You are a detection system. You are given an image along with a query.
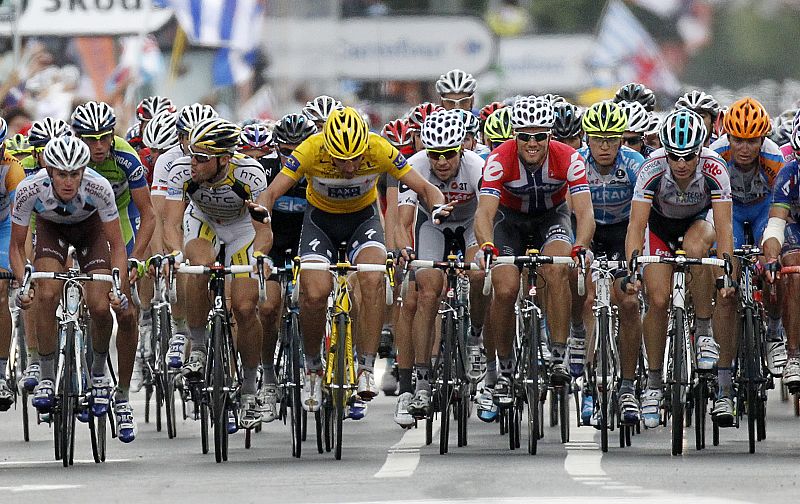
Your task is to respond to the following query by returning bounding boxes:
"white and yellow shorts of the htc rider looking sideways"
[183,203,256,278]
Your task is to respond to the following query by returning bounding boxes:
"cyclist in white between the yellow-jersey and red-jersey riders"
[395,111,485,428]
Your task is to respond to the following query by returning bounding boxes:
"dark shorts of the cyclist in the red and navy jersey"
[494,203,574,256]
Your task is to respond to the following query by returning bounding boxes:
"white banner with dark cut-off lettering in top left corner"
[0,0,172,36]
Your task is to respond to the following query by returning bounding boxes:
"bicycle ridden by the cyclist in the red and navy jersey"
[483,249,574,455]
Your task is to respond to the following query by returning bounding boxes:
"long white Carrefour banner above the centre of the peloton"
[264,16,495,80]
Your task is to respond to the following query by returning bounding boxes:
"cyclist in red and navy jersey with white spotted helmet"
[475,98,594,407]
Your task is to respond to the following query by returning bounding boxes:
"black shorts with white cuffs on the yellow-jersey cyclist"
[300,204,386,263]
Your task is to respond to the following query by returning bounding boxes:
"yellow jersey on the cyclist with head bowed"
[281,133,411,214]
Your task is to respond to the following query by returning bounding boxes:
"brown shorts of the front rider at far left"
[34,212,111,273]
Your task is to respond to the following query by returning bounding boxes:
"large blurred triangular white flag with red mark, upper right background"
[589,0,681,95]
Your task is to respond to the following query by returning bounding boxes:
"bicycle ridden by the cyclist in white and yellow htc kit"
[177,254,264,463]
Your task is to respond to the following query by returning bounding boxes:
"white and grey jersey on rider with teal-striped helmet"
[633,147,731,219]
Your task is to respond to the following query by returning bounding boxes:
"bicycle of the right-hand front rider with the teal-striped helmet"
[631,250,731,455]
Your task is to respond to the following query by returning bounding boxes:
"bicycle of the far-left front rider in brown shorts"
[22,265,120,467]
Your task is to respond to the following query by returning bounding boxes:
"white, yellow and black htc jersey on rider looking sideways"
[167,154,267,225]
